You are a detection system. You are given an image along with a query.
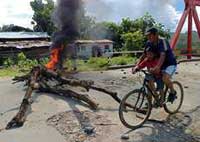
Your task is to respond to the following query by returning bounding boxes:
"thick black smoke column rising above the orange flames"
[52,0,82,40]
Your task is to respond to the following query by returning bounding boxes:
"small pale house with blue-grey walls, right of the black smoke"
[75,39,113,59]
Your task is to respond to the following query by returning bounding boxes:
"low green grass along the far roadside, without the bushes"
[0,56,136,77]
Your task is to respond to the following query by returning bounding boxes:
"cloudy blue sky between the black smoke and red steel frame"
[84,0,180,29]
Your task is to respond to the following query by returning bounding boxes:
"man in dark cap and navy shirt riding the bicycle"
[133,28,177,102]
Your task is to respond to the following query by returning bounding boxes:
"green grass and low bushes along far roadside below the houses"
[0,53,137,77]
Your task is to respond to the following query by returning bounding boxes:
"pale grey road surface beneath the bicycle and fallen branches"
[0,62,200,142]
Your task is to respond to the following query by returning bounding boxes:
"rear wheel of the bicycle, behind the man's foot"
[164,81,184,114]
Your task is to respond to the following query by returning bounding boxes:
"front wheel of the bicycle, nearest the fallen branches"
[119,89,152,129]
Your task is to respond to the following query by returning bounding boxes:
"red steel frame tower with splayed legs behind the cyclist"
[170,0,200,59]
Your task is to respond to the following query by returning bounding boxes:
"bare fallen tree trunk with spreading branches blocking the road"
[6,66,121,129]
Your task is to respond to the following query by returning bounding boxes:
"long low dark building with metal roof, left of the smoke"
[0,32,51,59]
